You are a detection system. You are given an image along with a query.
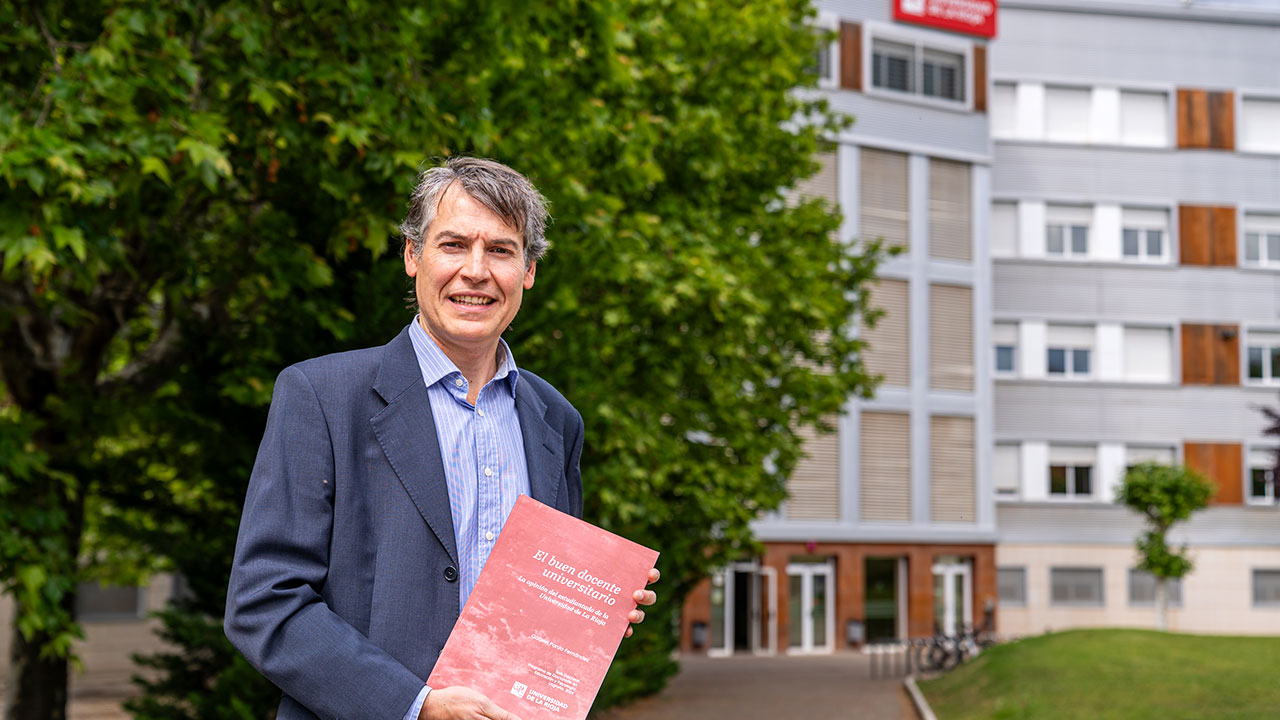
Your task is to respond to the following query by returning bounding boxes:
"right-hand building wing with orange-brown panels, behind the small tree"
[988,0,1280,634]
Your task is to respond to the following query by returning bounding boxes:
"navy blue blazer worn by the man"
[224,329,582,720]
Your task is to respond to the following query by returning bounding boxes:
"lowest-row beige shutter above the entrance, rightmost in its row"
[929,415,975,523]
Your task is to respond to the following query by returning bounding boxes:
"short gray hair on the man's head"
[401,158,550,266]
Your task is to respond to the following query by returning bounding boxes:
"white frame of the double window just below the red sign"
[863,20,974,111]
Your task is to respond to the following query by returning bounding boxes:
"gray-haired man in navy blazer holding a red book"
[225,158,658,720]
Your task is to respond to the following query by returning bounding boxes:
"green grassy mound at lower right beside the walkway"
[920,630,1280,720]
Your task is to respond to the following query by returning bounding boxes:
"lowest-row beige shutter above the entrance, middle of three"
[859,413,911,523]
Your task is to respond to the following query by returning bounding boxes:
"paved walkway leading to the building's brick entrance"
[599,652,918,720]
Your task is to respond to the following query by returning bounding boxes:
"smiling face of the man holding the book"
[404,184,536,363]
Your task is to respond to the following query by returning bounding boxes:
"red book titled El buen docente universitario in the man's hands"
[426,496,658,720]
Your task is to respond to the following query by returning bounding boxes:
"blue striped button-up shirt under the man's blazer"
[408,318,529,607]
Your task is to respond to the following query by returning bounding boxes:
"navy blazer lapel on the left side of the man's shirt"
[370,328,458,565]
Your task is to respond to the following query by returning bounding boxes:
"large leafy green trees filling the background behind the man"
[0,0,879,720]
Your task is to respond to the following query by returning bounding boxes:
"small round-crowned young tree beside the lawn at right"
[1119,462,1215,630]
